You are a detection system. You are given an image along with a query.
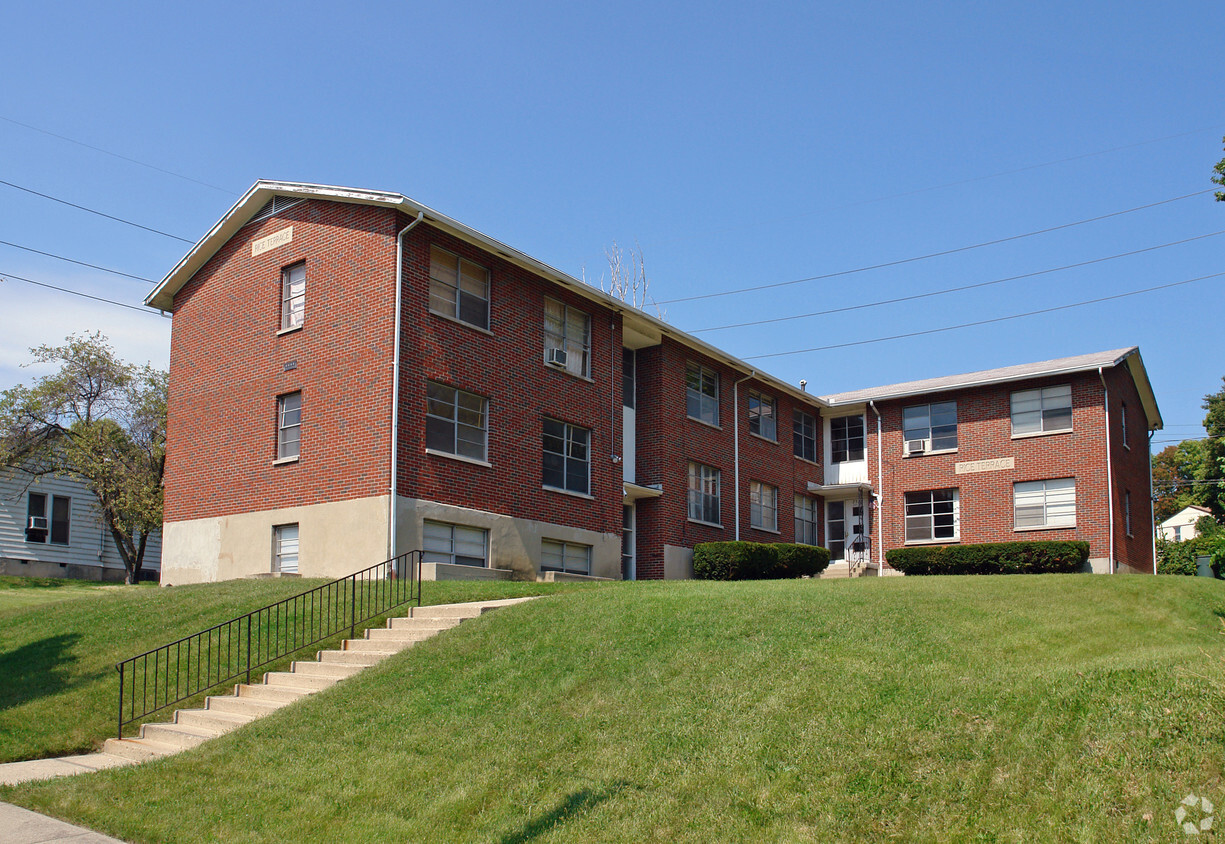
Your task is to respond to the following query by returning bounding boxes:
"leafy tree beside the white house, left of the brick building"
[0,333,167,583]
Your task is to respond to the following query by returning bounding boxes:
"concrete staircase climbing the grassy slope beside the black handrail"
[103,598,532,762]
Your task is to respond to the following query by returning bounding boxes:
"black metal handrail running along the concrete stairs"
[115,551,421,739]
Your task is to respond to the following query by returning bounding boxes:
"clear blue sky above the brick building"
[0,1,1225,441]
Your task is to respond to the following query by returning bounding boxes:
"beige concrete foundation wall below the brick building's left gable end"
[162,495,387,586]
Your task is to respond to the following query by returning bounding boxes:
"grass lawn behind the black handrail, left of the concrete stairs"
[0,578,595,762]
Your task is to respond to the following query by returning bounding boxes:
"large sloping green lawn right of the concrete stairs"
[0,575,1225,842]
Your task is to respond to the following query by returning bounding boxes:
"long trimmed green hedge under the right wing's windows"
[884,541,1089,575]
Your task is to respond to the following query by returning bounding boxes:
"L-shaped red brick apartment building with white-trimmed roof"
[147,181,1160,583]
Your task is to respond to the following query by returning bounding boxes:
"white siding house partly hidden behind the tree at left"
[0,470,162,581]
